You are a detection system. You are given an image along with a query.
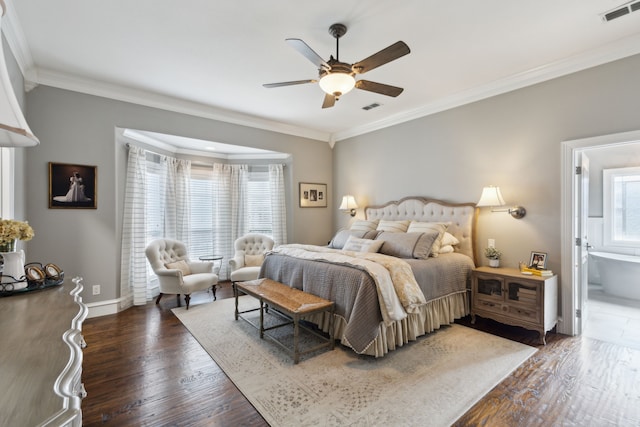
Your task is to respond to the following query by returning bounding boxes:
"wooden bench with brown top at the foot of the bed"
[234,279,335,364]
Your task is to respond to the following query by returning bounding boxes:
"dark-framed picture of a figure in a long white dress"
[49,162,98,209]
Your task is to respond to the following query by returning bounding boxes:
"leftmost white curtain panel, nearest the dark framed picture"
[120,146,151,310]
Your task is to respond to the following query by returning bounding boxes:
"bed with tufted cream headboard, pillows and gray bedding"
[260,197,477,357]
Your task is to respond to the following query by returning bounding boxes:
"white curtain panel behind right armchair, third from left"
[212,163,249,278]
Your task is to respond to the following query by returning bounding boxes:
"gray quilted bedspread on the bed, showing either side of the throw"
[260,253,473,353]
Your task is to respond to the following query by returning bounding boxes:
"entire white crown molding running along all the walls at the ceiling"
[2,0,640,148]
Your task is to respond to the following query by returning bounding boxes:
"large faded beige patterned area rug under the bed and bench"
[173,296,537,426]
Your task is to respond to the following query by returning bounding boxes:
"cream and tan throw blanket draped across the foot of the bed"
[272,244,426,325]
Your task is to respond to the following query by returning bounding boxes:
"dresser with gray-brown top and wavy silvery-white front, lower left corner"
[0,278,88,427]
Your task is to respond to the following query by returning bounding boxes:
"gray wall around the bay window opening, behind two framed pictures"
[23,86,333,302]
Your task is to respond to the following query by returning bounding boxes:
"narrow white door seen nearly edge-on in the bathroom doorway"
[574,152,589,334]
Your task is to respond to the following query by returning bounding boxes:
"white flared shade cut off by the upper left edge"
[0,0,40,147]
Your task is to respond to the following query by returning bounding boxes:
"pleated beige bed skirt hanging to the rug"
[305,291,469,357]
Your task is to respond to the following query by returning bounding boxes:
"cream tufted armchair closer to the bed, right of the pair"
[229,233,274,283]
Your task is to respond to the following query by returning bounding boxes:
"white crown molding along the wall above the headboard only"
[329,35,640,142]
